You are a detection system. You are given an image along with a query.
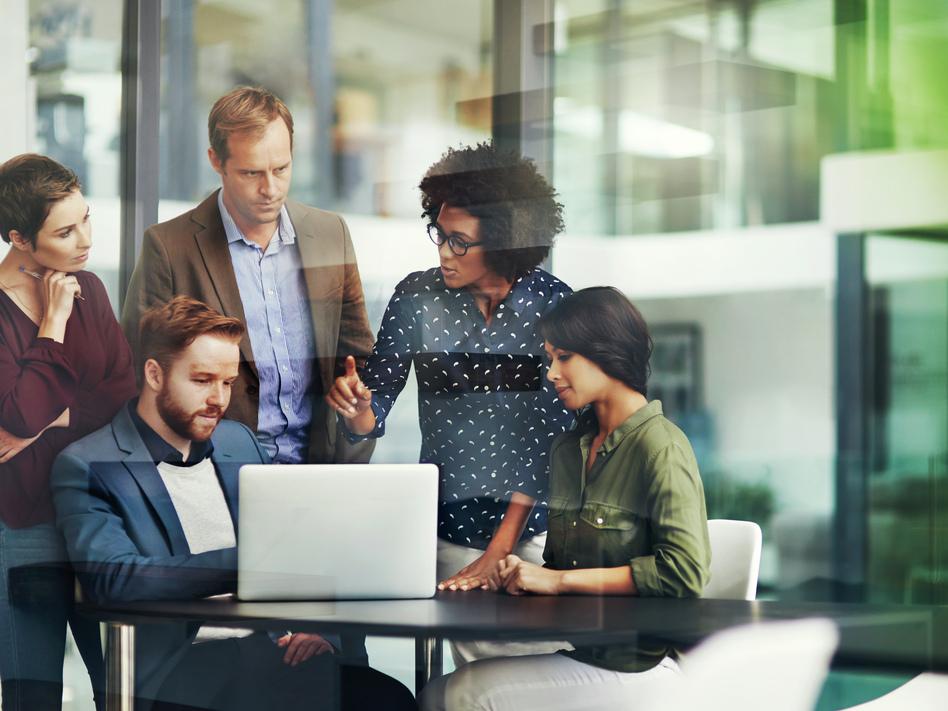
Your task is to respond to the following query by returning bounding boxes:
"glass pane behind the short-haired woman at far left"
[0,0,124,711]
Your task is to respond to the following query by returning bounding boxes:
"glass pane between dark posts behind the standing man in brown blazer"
[159,0,493,468]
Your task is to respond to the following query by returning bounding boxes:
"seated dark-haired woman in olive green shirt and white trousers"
[423,287,711,711]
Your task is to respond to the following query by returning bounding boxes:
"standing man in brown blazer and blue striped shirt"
[122,87,373,463]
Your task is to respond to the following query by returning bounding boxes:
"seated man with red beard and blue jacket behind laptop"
[52,296,414,711]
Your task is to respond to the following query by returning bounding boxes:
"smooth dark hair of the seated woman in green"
[537,286,652,396]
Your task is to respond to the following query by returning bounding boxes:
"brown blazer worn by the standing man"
[122,191,375,463]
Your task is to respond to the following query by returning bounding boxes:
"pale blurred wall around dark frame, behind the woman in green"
[638,289,836,512]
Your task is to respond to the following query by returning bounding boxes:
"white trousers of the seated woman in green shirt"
[420,654,681,711]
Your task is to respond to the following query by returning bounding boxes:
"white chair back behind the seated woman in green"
[701,519,763,600]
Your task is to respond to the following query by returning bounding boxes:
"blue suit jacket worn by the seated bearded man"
[51,407,268,699]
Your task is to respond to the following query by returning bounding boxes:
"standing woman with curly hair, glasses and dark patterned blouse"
[326,143,572,662]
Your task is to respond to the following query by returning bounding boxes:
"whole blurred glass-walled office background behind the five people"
[0,0,948,709]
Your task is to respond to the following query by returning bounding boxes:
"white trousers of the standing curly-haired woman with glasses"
[438,533,573,667]
